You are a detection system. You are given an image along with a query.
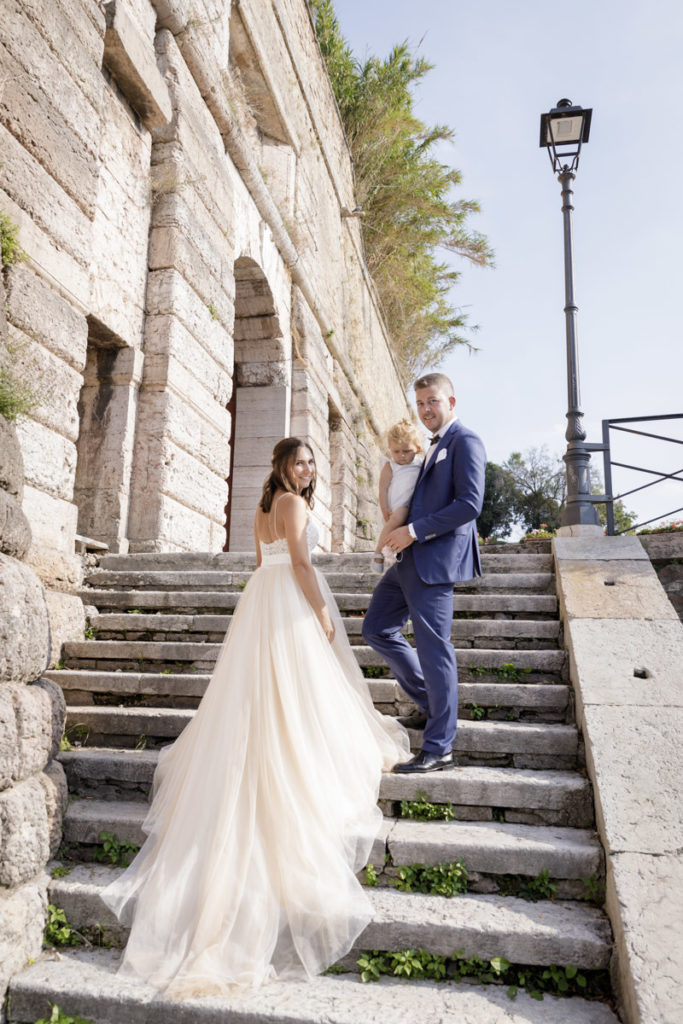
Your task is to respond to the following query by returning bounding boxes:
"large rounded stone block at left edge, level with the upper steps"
[0,555,50,683]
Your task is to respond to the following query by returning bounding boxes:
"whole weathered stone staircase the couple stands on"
[11,545,616,1024]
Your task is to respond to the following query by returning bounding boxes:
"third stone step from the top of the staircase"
[80,587,557,617]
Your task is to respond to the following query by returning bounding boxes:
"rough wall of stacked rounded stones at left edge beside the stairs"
[0,393,67,1002]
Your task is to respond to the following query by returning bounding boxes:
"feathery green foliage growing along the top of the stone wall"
[309,0,493,382]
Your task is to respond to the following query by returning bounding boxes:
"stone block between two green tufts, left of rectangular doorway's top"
[7,263,88,372]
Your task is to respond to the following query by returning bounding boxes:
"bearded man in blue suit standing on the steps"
[362,374,486,773]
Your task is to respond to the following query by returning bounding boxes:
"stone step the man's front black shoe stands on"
[58,748,593,828]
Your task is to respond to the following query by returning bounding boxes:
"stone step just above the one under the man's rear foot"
[49,669,569,715]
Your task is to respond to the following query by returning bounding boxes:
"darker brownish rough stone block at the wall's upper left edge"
[0,43,97,217]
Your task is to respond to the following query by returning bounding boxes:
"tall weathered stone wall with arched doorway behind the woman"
[0,0,407,585]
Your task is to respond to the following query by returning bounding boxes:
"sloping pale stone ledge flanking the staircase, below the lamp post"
[555,538,683,1024]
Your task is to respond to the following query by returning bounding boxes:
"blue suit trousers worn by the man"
[362,545,458,755]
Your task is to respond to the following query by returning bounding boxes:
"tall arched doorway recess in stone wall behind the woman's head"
[225,256,292,551]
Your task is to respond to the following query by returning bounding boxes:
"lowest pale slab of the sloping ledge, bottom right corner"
[607,853,683,1024]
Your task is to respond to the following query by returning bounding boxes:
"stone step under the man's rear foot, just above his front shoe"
[61,705,579,769]
